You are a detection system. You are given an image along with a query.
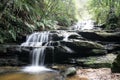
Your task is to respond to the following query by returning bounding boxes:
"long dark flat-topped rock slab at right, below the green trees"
[78,31,120,42]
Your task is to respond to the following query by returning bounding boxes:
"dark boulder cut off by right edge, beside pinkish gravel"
[112,53,120,73]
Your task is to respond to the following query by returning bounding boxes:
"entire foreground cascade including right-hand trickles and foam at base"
[21,31,73,73]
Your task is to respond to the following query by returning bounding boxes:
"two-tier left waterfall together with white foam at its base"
[21,31,50,72]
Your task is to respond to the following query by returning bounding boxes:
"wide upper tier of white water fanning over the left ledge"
[21,31,49,47]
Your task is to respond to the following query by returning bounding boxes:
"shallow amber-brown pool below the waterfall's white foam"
[0,68,62,80]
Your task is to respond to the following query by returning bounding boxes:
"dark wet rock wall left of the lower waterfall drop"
[0,45,33,66]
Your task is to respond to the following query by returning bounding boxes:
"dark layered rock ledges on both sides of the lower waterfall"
[0,30,120,67]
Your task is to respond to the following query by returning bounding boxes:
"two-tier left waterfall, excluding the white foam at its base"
[21,31,49,66]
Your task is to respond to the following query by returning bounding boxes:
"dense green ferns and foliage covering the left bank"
[0,0,75,43]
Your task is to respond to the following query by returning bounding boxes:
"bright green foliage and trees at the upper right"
[89,0,120,29]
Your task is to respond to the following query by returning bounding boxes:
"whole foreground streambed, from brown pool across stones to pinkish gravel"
[0,64,120,80]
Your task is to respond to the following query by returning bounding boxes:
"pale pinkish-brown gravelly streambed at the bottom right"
[66,68,120,80]
